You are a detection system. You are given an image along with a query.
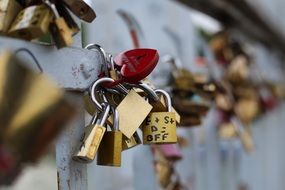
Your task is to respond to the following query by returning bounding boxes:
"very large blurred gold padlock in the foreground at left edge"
[0,52,75,161]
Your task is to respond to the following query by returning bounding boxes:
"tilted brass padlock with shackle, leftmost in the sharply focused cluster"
[72,105,110,163]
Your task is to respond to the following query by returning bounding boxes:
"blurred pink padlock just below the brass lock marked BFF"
[154,144,182,161]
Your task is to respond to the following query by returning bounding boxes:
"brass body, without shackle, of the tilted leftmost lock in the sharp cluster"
[73,124,106,163]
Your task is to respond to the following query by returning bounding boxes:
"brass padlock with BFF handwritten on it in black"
[142,90,177,144]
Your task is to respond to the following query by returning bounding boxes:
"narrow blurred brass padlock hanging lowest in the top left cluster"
[45,0,73,49]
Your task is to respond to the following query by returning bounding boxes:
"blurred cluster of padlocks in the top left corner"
[0,0,96,48]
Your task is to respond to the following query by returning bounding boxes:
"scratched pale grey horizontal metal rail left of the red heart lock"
[0,37,101,91]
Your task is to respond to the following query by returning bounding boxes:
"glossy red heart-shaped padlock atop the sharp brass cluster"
[114,49,159,83]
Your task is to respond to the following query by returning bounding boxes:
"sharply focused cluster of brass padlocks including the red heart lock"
[73,44,179,166]
